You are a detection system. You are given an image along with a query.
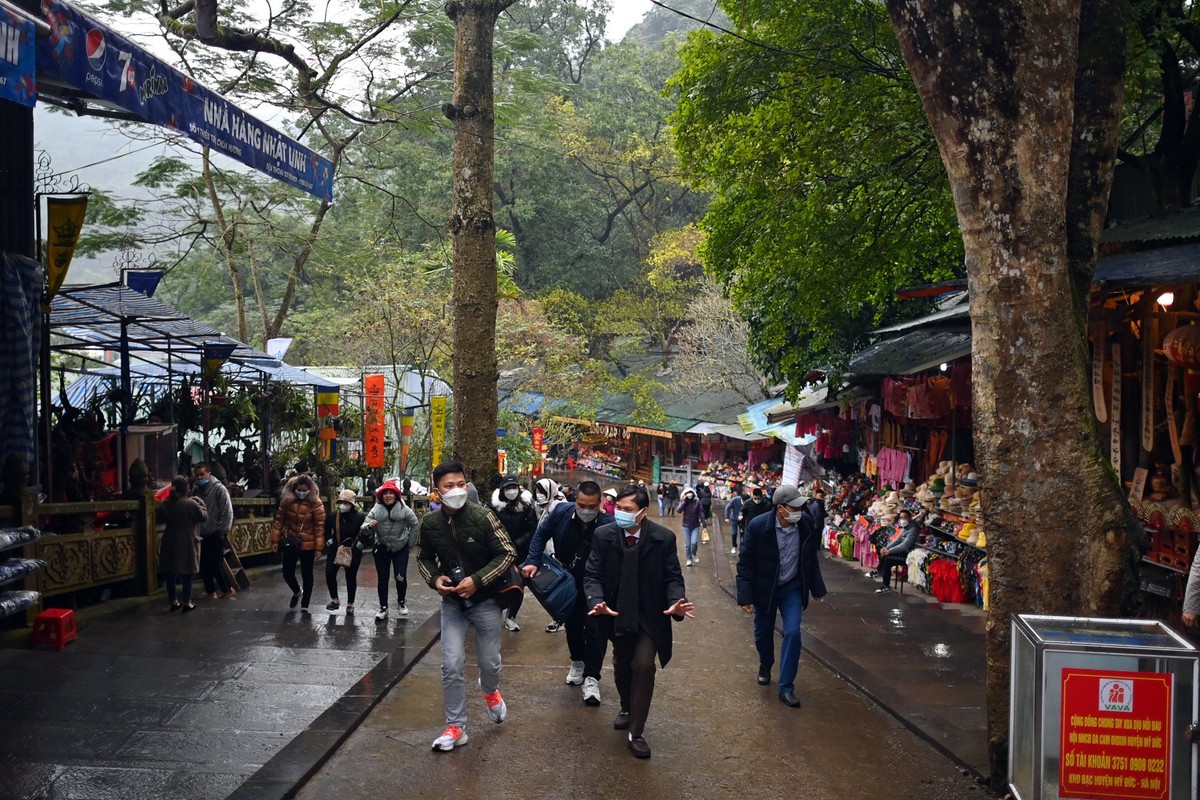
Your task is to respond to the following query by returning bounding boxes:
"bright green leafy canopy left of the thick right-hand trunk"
[671,0,961,390]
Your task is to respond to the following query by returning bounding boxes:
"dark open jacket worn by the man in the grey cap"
[738,513,826,609]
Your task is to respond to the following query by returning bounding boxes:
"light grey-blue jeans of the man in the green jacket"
[442,597,500,728]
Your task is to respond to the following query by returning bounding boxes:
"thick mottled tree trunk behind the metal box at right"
[888,0,1136,783]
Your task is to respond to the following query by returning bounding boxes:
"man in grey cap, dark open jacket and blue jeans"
[738,486,826,708]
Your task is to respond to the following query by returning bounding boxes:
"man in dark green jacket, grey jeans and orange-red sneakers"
[416,462,516,751]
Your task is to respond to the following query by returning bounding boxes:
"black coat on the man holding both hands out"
[583,519,686,667]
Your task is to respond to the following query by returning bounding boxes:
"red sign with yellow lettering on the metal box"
[1058,667,1172,800]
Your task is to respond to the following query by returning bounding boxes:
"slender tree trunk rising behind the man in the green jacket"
[444,0,515,488]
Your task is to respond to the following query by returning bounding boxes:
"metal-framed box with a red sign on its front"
[1008,614,1200,800]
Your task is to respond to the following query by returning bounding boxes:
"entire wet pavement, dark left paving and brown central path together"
[0,484,988,800]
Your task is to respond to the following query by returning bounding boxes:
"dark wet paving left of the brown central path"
[0,563,437,800]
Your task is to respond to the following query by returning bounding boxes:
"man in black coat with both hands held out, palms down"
[584,486,695,758]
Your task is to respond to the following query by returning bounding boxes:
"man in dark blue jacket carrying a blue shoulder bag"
[521,481,612,705]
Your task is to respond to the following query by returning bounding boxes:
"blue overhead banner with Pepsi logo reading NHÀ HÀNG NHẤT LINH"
[37,0,334,200]
